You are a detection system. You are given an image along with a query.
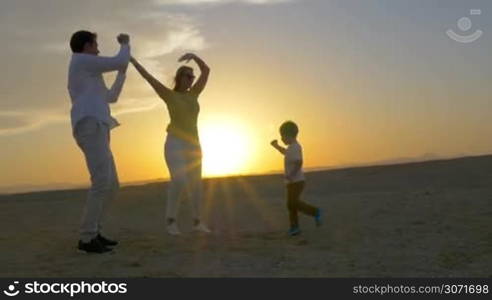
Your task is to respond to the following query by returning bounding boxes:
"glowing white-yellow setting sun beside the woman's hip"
[200,122,250,176]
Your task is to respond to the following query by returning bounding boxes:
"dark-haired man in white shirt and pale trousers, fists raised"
[68,31,130,253]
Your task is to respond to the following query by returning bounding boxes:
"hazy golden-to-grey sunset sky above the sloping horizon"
[0,0,492,192]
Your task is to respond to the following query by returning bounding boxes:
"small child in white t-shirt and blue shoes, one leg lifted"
[271,121,321,236]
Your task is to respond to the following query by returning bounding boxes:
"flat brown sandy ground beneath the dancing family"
[0,156,492,277]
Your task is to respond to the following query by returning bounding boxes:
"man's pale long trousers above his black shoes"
[74,117,119,242]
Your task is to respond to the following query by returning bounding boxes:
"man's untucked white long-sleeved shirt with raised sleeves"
[68,45,130,130]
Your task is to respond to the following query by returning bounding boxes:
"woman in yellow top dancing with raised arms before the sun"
[130,53,210,235]
